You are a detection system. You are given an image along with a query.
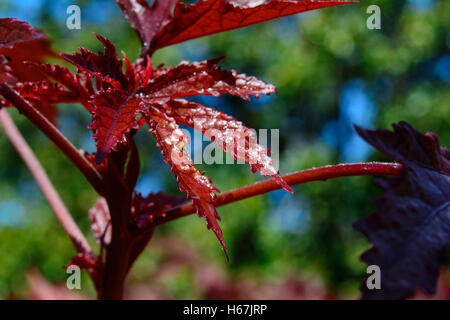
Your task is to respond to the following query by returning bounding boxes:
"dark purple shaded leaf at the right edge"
[354,122,450,299]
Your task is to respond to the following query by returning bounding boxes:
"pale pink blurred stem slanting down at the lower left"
[0,110,92,253]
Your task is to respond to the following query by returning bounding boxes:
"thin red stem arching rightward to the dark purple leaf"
[150,162,402,228]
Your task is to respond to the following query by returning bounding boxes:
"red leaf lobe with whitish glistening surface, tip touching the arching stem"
[167,100,293,192]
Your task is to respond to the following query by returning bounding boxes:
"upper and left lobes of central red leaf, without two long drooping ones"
[57,35,275,163]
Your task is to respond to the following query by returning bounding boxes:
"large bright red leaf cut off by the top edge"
[116,0,355,55]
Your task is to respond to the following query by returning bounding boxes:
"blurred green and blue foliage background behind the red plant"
[0,0,450,298]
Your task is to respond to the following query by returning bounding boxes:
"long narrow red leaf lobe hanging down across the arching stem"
[146,107,228,259]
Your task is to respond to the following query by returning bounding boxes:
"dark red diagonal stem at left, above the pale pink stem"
[0,83,104,195]
